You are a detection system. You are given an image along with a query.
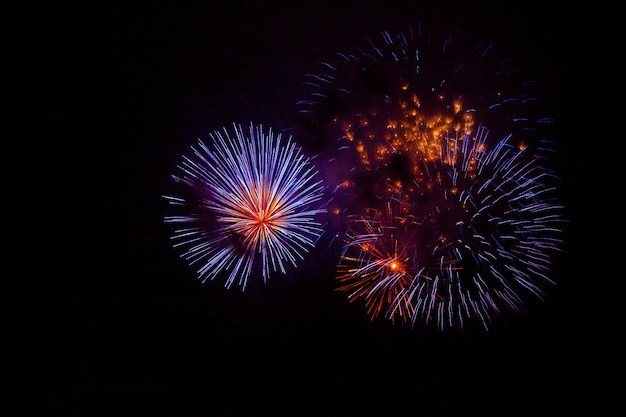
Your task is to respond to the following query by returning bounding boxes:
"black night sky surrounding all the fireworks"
[2,0,596,416]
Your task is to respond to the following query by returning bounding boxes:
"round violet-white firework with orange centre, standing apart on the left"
[165,120,325,289]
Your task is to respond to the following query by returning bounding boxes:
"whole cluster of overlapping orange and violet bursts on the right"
[298,26,564,330]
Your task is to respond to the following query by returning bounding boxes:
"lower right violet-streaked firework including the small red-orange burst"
[337,131,564,330]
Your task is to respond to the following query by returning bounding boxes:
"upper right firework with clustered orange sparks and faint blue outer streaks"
[297,24,553,220]
